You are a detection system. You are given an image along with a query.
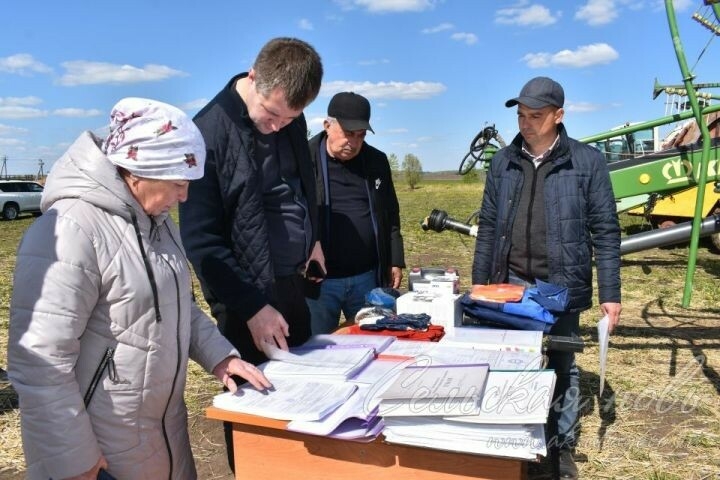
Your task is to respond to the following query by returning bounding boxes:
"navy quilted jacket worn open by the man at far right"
[472,124,620,311]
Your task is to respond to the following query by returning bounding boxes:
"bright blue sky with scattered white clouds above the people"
[0,0,720,175]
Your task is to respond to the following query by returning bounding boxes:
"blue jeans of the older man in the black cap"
[305,270,377,335]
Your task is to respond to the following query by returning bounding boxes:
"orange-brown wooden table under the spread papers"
[206,407,527,480]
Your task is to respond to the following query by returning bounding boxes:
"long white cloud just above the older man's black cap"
[322,80,447,100]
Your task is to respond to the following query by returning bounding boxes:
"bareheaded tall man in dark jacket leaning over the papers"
[180,38,325,465]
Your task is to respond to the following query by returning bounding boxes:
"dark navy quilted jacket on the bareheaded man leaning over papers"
[180,73,318,321]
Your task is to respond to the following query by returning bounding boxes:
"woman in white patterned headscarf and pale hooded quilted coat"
[8,98,270,480]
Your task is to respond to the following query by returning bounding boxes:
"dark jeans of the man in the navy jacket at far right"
[508,272,580,449]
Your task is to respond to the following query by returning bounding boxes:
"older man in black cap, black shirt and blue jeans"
[306,92,405,334]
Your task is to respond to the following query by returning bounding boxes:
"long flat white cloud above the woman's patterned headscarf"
[59,60,187,87]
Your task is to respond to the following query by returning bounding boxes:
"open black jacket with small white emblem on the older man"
[309,132,405,287]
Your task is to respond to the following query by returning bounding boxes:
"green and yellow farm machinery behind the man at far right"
[422,0,720,307]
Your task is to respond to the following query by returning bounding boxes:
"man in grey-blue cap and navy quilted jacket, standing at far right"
[472,77,622,478]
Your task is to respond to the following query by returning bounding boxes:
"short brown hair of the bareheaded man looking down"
[253,37,323,110]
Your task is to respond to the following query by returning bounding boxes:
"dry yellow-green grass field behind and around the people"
[0,181,720,480]
